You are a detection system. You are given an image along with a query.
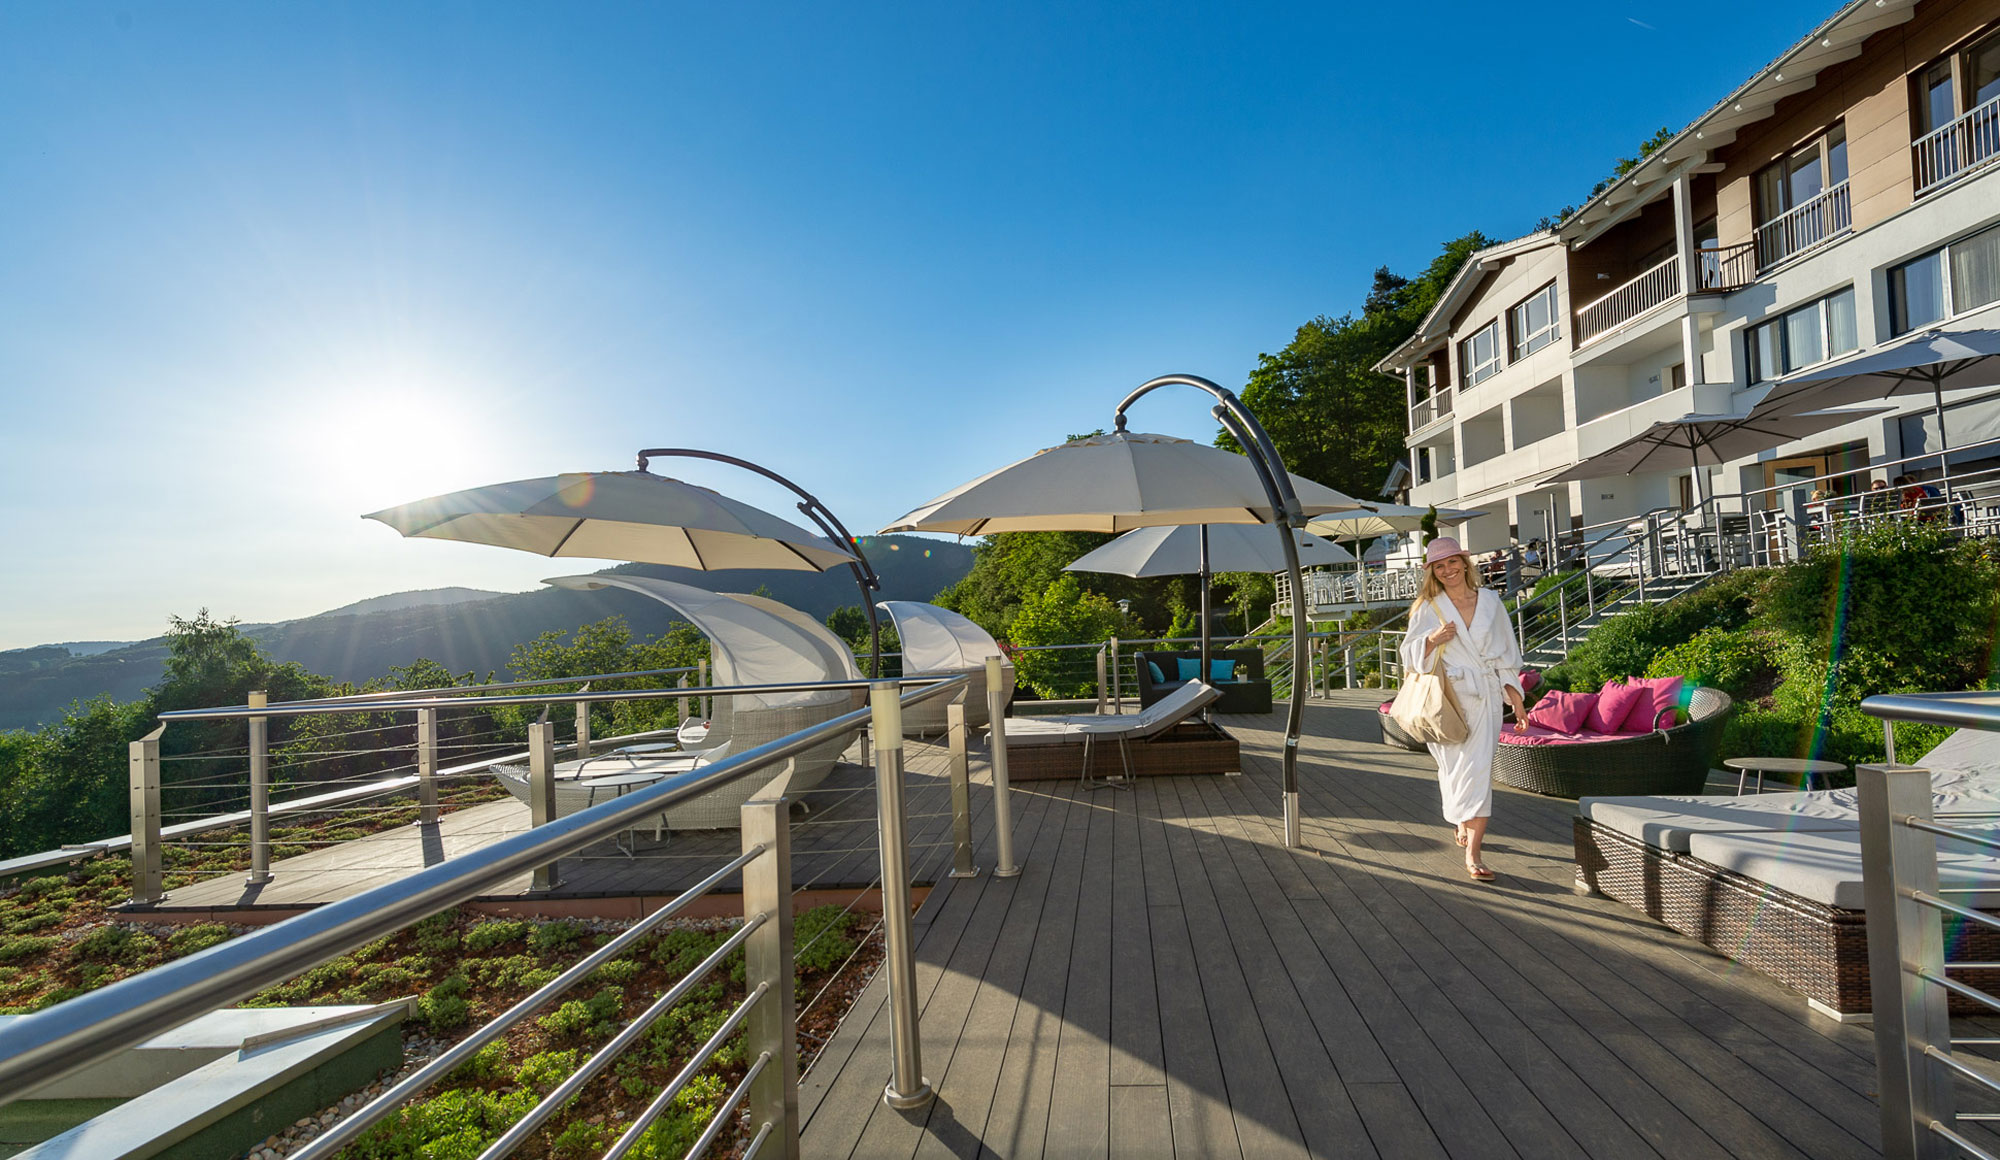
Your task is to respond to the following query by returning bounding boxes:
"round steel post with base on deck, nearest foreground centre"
[868,680,934,1110]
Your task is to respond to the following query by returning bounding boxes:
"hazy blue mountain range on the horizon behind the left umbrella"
[0,536,972,728]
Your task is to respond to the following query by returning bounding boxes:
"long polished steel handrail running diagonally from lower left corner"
[0,674,970,1102]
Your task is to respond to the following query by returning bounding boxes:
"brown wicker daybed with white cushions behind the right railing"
[1574,730,2000,1018]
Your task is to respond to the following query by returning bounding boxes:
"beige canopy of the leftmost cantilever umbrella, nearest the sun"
[362,472,854,572]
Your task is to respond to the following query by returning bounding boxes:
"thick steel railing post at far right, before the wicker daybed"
[1854,766,1952,1160]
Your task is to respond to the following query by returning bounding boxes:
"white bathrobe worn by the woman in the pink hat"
[1402,588,1520,826]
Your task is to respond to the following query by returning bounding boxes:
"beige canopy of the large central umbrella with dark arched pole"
[882,432,1362,536]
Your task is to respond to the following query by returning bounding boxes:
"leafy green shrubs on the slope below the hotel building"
[1546,522,2000,780]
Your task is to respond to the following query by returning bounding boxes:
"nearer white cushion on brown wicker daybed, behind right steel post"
[1688,830,2000,910]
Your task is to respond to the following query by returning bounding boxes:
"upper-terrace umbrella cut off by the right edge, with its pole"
[1758,330,2000,484]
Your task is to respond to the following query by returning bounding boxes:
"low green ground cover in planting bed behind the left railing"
[0,858,880,1160]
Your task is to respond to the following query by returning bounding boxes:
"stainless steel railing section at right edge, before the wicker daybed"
[1854,692,2000,1160]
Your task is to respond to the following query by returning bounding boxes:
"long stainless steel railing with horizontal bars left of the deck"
[0,676,992,1160]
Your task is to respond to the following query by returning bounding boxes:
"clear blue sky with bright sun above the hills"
[0,0,1830,648]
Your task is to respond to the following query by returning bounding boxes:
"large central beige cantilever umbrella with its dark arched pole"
[884,374,1368,848]
